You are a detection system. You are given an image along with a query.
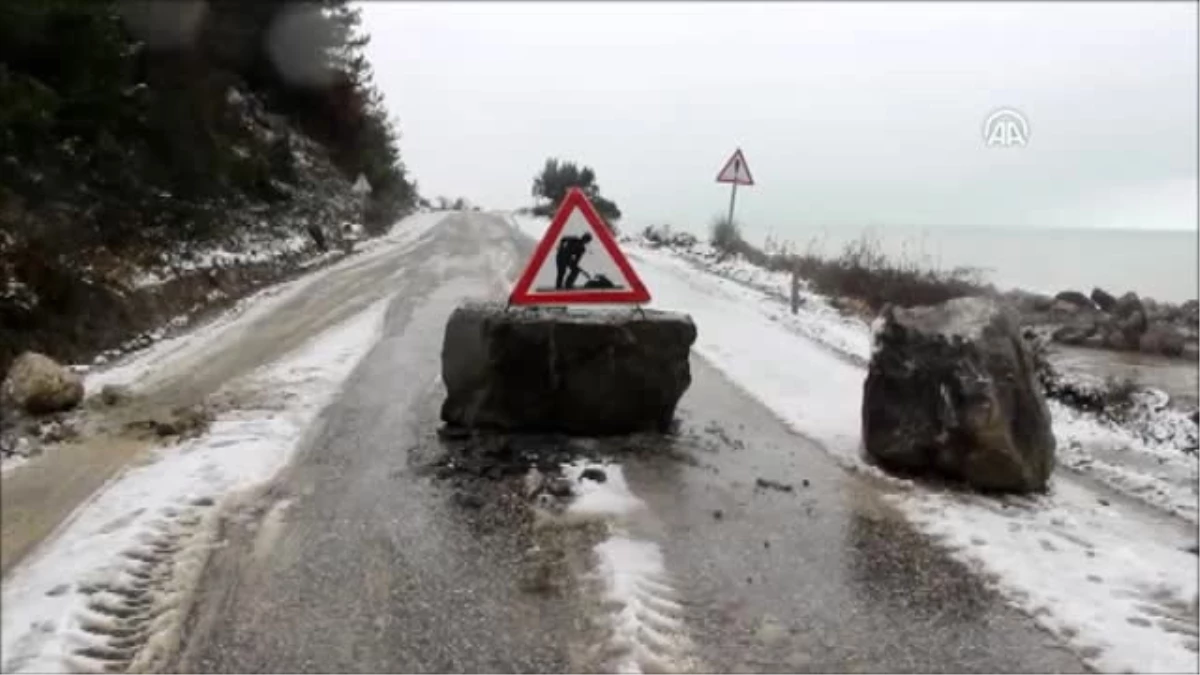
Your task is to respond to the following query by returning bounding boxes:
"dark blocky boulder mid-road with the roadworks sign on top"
[442,304,696,436]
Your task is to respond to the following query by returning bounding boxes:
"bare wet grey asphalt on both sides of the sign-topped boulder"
[170,214,1084,673]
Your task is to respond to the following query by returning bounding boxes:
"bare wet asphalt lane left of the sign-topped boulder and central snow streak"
[172,215,570,673]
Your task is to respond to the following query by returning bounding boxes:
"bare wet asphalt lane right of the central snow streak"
[609,358,1084,673]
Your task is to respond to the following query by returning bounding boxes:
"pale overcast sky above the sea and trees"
[362,1,1198,233]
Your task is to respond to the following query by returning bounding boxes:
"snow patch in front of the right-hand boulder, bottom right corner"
[896,478,1200,673]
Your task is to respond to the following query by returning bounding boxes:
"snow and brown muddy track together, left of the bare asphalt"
[0,214,520,673]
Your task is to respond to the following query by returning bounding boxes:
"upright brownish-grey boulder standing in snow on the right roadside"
[863,298,1055,492]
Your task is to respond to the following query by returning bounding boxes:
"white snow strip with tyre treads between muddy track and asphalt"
[0,300,386,673]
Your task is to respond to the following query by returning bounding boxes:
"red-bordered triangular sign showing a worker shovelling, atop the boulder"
[509,187,650,305]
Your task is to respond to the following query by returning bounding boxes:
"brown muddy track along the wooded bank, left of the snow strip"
[0,214,451,573]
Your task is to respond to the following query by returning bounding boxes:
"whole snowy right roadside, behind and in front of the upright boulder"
[625,239,1200,673]
